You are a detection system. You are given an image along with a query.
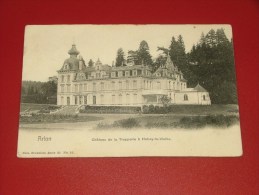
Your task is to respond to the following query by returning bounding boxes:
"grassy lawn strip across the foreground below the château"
[20,104,239,129]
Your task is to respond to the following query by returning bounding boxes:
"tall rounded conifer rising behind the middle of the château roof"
[137,40,153,66]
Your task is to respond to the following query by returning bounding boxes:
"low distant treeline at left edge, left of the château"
[21,81,57,104]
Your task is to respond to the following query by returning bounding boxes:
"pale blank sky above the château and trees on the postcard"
[22,25,232,81]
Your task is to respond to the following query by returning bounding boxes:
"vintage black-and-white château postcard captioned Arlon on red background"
[17,25,242,158]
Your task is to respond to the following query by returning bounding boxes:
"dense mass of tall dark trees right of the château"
[188,29,237,104]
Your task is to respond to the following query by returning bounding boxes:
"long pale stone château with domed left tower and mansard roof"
[57,45,211,106]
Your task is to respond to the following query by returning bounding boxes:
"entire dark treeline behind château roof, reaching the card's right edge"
[115,28,237,104]
